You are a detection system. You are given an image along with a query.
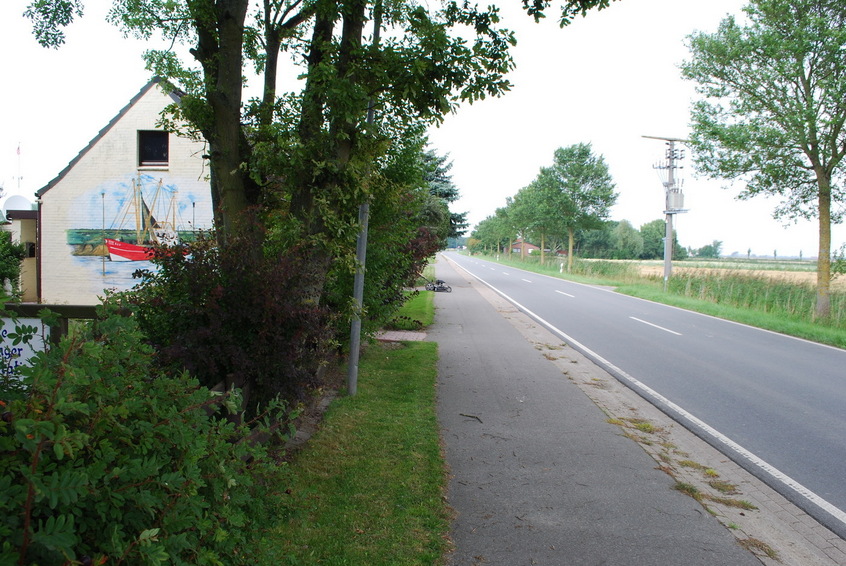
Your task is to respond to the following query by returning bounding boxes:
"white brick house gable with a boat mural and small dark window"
[36,79,212,305]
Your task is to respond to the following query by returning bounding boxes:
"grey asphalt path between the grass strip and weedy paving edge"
[428,260,761,566]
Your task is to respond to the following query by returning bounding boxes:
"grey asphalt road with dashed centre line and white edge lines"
[447,253,846,537]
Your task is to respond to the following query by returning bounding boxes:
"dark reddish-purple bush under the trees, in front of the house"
[115,232,332,411]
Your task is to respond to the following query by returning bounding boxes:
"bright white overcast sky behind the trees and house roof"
[0,0,846,258]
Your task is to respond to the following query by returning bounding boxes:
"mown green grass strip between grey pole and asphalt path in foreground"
[265,342,449,565]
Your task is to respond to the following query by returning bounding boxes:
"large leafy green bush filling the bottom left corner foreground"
[0,312,284,565]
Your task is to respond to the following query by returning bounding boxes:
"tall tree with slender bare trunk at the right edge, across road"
[682,0,846,318]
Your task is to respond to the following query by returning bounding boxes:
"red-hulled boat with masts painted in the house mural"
[104,174,179,261]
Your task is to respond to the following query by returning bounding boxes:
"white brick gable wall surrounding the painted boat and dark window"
[38,85,212,305]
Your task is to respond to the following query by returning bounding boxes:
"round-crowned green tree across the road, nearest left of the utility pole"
[535,143,617,270]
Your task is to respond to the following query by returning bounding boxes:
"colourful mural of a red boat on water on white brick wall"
[66,173,212,294]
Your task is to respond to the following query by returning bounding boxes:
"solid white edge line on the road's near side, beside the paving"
[453,262,846,525]
